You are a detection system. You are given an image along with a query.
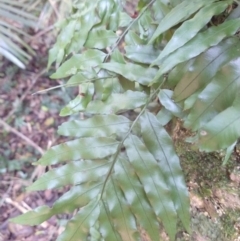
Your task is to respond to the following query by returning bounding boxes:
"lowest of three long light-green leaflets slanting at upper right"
[152,19,240,83]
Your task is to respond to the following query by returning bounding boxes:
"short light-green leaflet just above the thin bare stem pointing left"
[51,49,106,79]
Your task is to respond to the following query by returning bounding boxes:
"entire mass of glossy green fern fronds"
[9,0,240,241]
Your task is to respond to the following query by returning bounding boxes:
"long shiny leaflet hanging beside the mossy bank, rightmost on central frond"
[140,113,190,233]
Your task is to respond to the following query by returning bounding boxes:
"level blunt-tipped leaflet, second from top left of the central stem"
[58,115,131,137]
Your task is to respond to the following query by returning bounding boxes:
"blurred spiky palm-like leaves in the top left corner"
[0,0,71,69]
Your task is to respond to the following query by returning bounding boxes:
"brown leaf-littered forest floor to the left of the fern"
[0,29,76,241]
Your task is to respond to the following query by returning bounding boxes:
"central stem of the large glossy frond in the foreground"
[100,76,167,199]
